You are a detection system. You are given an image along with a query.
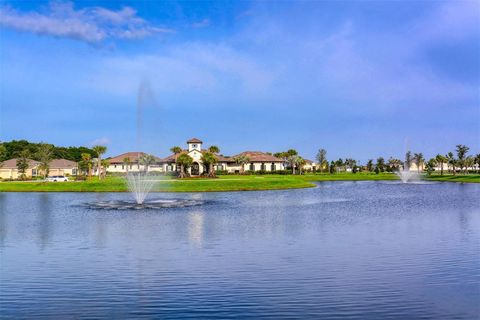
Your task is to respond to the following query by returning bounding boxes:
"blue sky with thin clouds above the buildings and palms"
[0,1,480,162]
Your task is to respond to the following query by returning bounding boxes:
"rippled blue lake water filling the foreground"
[0,182,480,319]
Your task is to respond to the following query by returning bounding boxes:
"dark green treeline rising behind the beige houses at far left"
[0,140,97,162]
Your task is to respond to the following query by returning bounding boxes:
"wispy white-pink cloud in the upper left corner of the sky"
[0,2,173,43]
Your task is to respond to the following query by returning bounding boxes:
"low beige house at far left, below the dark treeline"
[0,158,78,179]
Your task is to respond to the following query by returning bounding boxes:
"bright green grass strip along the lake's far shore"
[0,173,480,192]
